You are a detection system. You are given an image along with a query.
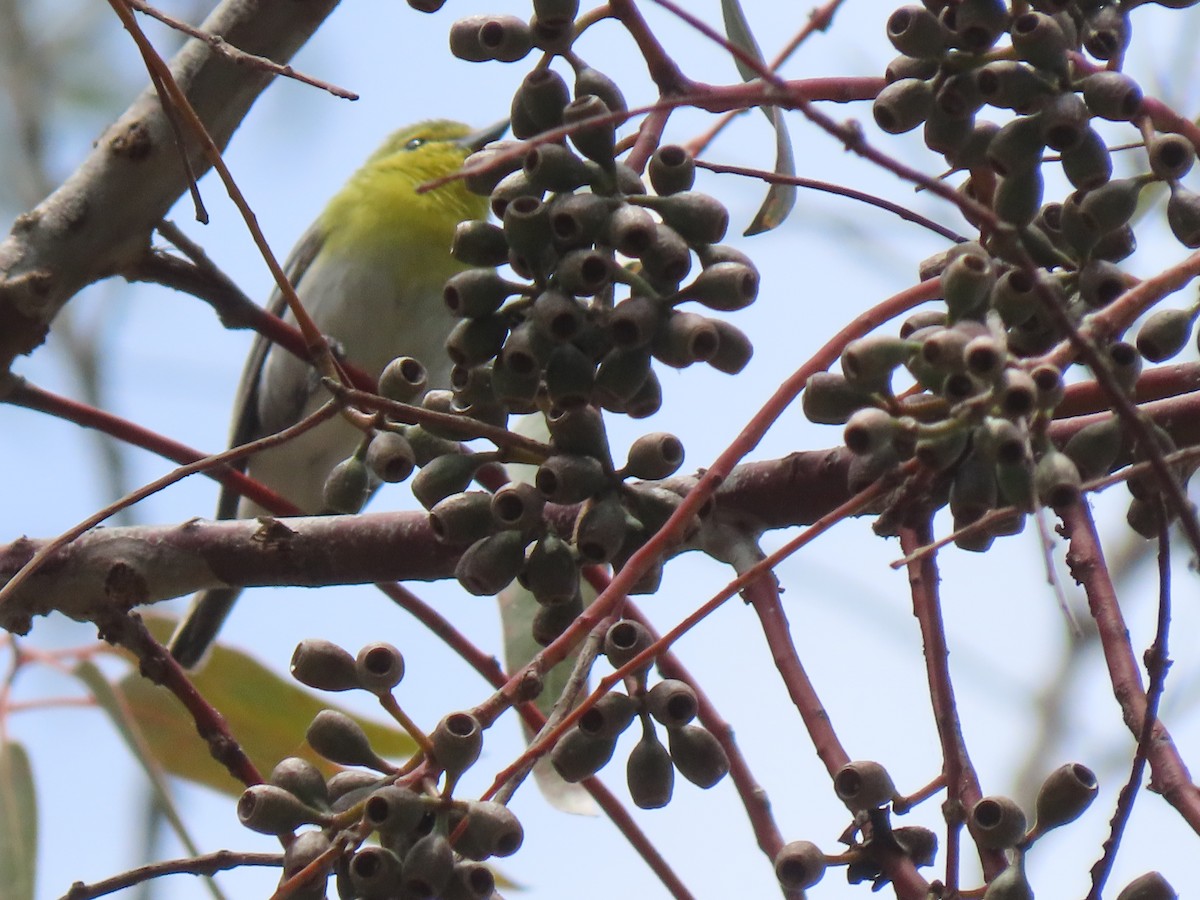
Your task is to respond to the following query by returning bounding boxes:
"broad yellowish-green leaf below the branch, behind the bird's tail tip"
[115,616,416,796]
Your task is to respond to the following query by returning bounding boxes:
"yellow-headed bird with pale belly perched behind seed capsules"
[168,120,508,668]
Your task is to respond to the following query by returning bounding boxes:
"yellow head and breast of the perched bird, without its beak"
[320,121,487,278]
